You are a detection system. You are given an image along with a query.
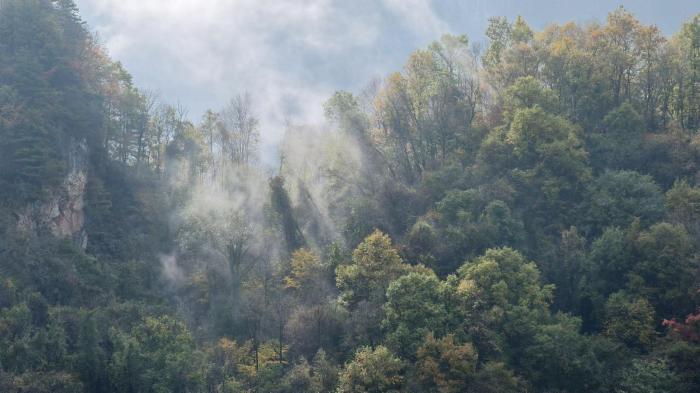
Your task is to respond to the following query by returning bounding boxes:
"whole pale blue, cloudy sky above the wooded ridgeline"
[76,0,700,158]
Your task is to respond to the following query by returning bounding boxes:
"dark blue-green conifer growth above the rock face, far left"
[0,0,93,204]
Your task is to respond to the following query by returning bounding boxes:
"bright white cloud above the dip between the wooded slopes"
[78,0,446,163]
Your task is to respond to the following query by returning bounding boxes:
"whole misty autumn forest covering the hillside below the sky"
[0,0,700,393]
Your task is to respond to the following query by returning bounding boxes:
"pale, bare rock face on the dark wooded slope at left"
[17,140,88,249]
